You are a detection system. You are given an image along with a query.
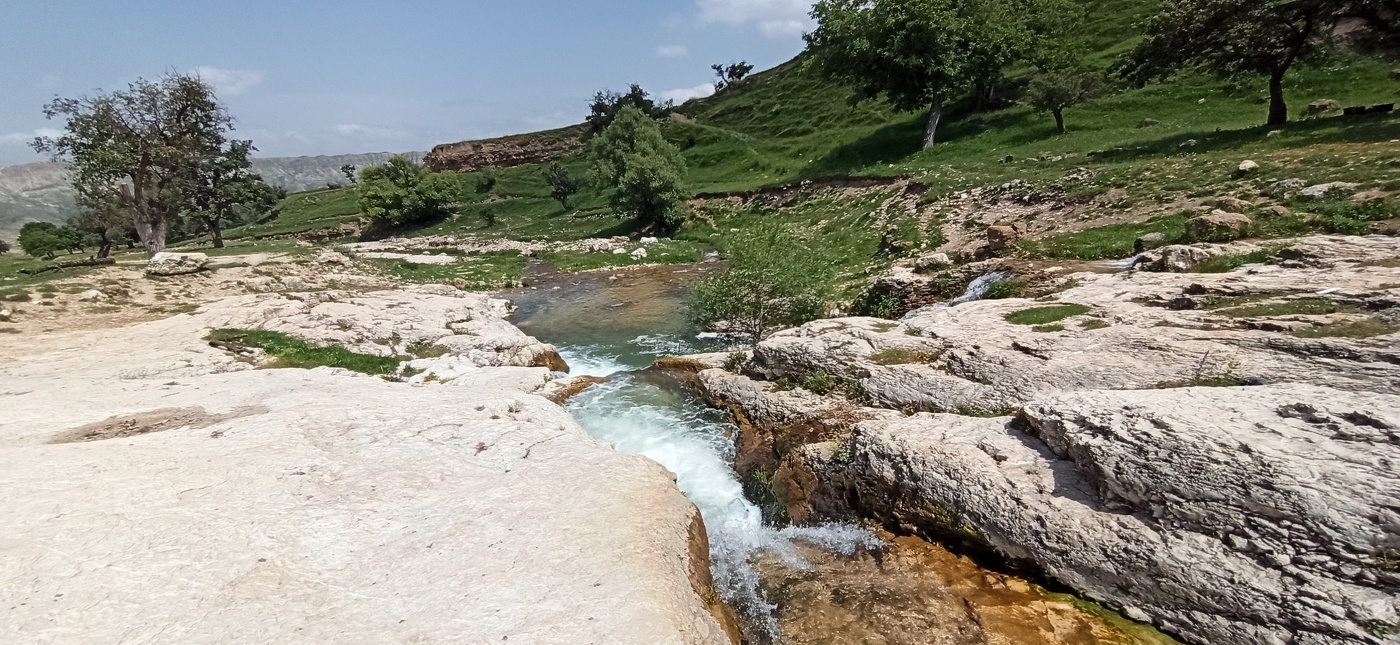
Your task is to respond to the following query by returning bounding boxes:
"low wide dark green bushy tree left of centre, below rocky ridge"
[360,154,454,228]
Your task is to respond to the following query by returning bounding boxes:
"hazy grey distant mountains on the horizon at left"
[0,153,423,234]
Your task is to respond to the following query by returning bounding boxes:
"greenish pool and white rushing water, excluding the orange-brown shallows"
[508,267,881,642]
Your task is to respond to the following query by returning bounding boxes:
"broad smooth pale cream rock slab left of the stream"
[0,290,738,645]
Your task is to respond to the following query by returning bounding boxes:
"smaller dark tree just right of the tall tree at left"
[183,140,277,249]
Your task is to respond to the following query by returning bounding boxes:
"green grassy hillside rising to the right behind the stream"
[203,0,1400,293]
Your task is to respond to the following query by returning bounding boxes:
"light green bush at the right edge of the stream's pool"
[690,224,832,343]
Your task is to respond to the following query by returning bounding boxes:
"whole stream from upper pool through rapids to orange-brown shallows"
[503,264,1173,645]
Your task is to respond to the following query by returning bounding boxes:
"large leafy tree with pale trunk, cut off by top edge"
[804,0,1070,148]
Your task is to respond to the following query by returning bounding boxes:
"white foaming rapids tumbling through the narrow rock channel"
[560,336,881,642]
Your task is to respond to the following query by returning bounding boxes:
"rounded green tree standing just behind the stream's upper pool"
[588,105,686,234]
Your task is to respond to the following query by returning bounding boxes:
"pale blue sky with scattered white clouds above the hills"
[0,0,812,165]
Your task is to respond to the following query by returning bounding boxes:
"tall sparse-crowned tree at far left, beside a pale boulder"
[32,74,232,255]
